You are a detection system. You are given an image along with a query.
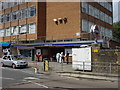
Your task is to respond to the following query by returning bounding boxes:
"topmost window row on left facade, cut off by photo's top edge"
[0,0,25,10]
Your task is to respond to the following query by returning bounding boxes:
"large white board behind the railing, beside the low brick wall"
[72,47,91,71]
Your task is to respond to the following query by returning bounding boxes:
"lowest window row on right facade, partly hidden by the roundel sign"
[82,19,112,38]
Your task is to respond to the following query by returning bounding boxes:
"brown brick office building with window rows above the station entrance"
[0,2,113,59]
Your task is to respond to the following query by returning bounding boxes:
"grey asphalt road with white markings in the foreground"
[0,67,118,90]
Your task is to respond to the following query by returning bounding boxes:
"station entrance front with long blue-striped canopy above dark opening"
[14,41,103,62]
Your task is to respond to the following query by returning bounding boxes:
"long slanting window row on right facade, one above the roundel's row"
[82,2,112,25]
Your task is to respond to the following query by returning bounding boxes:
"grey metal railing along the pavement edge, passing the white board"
[28,61,120,74]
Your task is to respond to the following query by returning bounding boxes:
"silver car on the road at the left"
[1,55,28,68]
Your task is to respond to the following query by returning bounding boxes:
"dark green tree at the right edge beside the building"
[113,22,120,39]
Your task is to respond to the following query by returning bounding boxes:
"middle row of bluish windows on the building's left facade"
[0,6,36,23]
